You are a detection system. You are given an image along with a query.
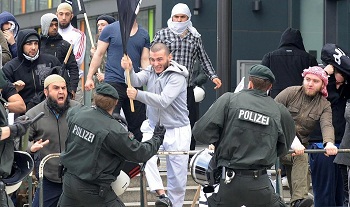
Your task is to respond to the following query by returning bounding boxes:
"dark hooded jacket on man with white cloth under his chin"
[3,29,61,109]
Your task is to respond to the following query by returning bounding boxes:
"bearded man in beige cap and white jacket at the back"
[56,2,86,103]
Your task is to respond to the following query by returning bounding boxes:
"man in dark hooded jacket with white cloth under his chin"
[3,29,61,110]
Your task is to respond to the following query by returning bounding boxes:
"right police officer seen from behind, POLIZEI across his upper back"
[192,65,295,207]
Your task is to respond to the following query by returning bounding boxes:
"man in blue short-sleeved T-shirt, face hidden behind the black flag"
[85,21,150,141]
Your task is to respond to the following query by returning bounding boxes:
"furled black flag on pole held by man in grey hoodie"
[117,0,142,54]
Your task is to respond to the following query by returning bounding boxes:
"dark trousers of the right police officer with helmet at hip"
[208,174,286,207]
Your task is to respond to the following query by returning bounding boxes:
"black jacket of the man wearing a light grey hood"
[40,34,79,92]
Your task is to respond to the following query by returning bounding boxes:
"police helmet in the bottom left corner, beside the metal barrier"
[2,151,34,194]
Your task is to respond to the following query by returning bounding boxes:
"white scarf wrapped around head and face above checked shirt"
[168,3,201,37]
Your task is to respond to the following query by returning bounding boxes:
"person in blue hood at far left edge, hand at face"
[0,11,19,58]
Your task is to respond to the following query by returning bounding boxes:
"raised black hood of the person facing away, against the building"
[278,27,305,51]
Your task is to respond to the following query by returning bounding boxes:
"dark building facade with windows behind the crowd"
[0,0,350,113]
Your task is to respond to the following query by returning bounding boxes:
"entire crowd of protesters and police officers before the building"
[0,3,350,207]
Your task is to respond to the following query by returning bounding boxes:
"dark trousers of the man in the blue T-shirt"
[109,82,146,141]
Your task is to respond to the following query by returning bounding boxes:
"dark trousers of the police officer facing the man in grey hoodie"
[57,173,125,207]
